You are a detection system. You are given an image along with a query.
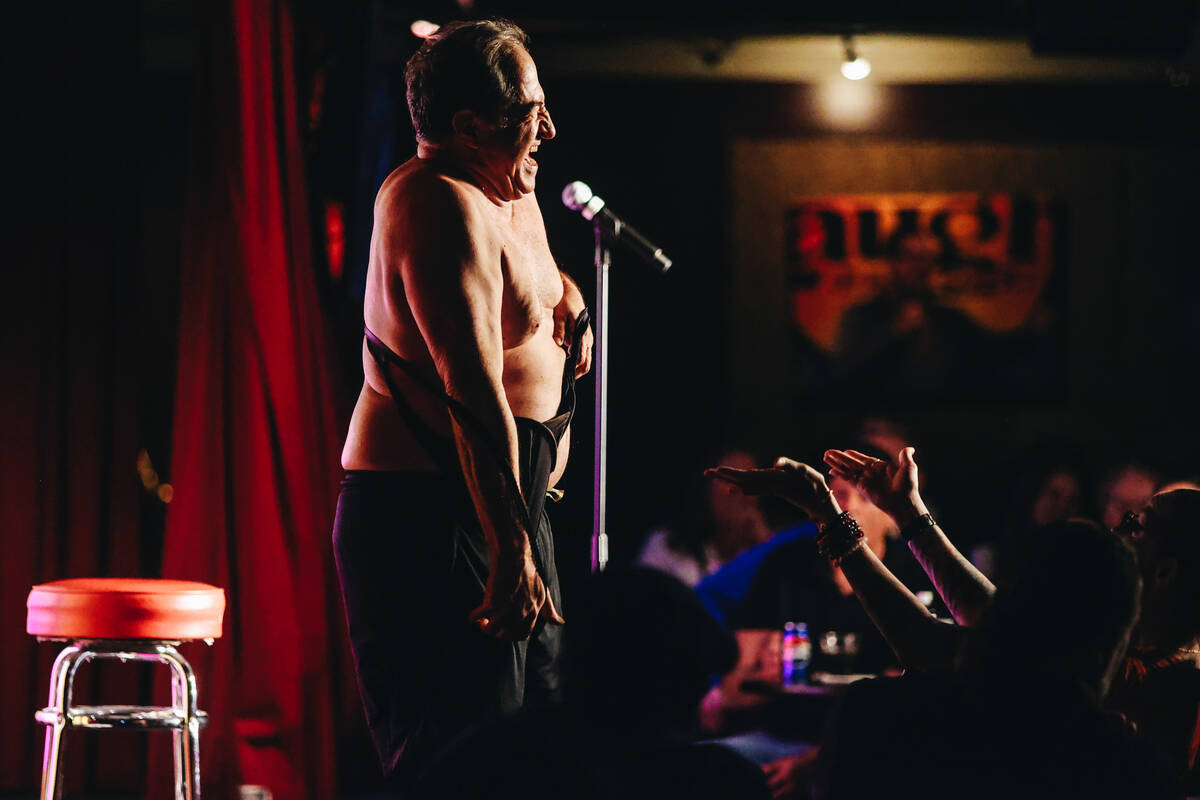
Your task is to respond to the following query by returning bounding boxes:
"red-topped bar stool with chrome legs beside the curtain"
[25,578,224,800]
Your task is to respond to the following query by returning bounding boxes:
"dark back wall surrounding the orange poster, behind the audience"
[535,76,1200,587]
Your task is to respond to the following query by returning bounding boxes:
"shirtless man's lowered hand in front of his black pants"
[470,549,564,640]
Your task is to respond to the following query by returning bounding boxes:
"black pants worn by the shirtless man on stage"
[334,471,562,787]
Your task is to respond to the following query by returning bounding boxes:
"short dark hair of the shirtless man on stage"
[404,19,529,142]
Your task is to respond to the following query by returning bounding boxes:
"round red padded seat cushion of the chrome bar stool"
[25,578,224,640]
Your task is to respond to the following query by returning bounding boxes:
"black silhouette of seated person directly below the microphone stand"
[418,567,770,800]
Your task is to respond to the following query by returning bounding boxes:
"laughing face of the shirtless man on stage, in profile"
[480,49,554,200]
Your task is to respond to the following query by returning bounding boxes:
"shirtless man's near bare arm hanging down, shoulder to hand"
[380,180,562,639]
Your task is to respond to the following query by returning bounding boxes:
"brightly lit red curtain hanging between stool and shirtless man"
[150,0,356,800]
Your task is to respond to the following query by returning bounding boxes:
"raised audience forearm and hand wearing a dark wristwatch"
[824,447,996,625]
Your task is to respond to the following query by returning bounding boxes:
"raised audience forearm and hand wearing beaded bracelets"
[706,458,962,669]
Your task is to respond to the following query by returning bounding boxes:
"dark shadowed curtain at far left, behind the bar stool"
[0,5,152,795]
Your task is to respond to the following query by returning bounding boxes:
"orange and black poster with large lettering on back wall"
[785,193,1066,404]
